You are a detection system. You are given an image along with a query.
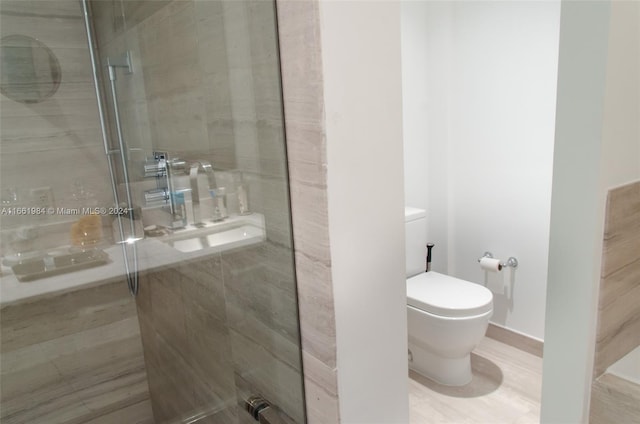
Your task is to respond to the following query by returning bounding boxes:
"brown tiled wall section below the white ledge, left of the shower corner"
[0,281,153,424]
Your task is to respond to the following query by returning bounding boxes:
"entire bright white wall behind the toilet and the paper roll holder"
[402,1,560,339]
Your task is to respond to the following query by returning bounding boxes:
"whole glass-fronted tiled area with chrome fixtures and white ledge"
[0,0,306,424]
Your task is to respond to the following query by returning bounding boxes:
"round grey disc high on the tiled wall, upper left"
[0,35,62,103]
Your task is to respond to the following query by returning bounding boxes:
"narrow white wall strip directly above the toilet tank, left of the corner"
[402,1,453,273]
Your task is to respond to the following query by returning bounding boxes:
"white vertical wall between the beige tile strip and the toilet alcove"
[320,2,409,424]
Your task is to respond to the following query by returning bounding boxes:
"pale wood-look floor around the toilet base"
[409,337,542,424]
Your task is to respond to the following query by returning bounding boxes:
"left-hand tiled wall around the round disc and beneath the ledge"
[0,0,151,423]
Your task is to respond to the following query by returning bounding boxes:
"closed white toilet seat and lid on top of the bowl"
[407,271,493,317]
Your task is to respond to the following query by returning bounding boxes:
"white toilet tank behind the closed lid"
[404,206,427,278]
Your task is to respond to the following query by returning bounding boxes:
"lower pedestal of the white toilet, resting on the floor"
[409,343,473,386]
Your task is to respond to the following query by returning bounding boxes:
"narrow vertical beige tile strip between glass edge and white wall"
[277,1,339,424]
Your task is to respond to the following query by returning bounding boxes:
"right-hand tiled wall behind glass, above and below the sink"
[87,0,304,424]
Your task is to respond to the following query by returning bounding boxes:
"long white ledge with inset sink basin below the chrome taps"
[0,213,266,307]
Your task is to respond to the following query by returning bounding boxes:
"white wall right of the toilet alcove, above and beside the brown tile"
[541,1,640,423]
